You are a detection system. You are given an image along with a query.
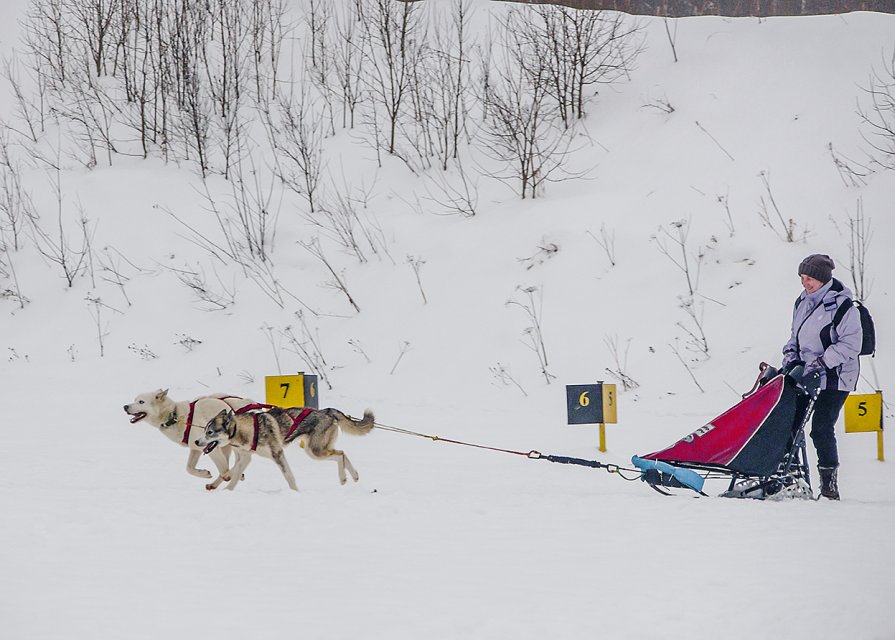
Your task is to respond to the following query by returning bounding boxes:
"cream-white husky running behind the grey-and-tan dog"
[124,389,254,491]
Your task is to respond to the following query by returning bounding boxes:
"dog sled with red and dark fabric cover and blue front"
[631,363,819,500]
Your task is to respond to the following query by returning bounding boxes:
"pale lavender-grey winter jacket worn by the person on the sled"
[783,278,863,391]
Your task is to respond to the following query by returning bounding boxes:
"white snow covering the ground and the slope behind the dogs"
[0,0,895,640]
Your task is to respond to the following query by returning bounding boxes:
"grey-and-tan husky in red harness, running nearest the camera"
[195,407,375,491]
